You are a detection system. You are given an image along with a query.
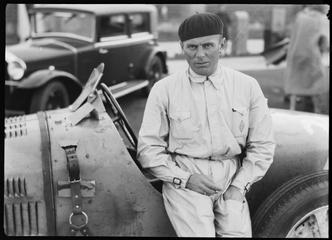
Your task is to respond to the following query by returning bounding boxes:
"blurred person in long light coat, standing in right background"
[284,5,330,113]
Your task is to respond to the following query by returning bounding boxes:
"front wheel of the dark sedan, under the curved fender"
[30,81,69,113]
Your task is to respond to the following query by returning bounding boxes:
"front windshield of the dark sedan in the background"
[34,11,95,40]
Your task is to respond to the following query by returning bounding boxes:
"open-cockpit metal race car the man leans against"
[3,64,329,238]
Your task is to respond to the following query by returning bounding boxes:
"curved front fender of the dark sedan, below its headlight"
[18,69,82,89]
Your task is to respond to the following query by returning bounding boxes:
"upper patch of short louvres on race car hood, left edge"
[5,116,28,138]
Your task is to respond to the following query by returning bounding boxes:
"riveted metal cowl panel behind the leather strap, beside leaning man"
[48,106,174,236]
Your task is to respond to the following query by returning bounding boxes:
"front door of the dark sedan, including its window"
[96,13,129,86]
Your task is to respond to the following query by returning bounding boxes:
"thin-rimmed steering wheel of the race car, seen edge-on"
[100,83,137,149]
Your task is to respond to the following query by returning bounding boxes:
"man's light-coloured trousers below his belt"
[162,157,252,237]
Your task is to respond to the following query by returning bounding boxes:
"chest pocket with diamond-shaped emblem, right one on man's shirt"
[232,106,249,137]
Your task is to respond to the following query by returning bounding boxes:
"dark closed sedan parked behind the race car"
[5,4,168,116]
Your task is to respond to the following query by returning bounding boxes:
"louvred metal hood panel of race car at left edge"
[3,115,48,236]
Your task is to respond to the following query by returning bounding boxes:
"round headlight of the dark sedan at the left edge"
[6,51,27,80]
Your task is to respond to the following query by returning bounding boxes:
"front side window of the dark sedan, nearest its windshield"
[100,15,127,40]
